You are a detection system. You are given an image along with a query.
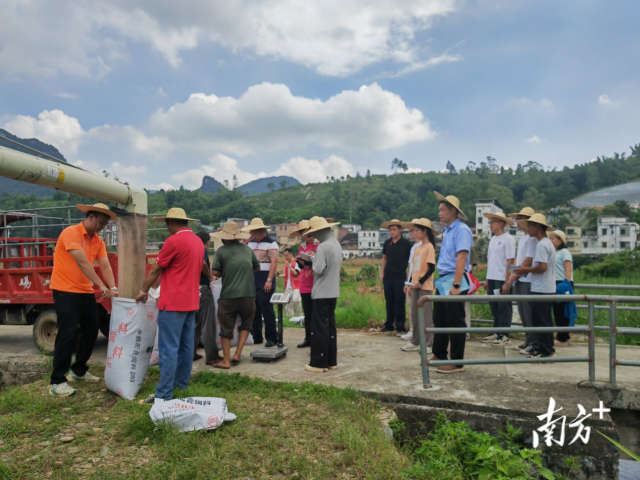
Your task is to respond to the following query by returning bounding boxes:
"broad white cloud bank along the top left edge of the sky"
[0,0,456,78]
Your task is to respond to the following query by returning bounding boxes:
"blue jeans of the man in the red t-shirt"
[156,310,196,400]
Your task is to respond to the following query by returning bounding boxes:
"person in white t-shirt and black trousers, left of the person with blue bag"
[515,213,556,358]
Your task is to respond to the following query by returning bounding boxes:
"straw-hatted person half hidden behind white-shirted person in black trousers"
[509,207,537,350]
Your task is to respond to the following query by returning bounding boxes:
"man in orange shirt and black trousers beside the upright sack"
[49,203,118,397]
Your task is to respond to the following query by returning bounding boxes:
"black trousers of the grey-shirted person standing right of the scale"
[309,298,338,368]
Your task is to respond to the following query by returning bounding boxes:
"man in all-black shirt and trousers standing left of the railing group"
[380,219,413,336]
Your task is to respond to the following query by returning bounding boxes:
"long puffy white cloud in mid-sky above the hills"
[150,83,436,155]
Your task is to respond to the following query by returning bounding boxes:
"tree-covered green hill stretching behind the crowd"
[0,145,640,227]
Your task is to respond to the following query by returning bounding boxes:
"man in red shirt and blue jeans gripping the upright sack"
[136,208,204,403]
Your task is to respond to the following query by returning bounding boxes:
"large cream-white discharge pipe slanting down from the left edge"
[0,147,147,215]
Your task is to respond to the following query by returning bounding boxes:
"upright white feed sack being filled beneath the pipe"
[104,298,158,400]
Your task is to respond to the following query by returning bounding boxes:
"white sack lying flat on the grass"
[149,397,236,432]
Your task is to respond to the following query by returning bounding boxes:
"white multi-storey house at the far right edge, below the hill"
[582,215,640,255]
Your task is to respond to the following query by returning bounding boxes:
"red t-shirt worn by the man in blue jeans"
[156,228,203,312]
